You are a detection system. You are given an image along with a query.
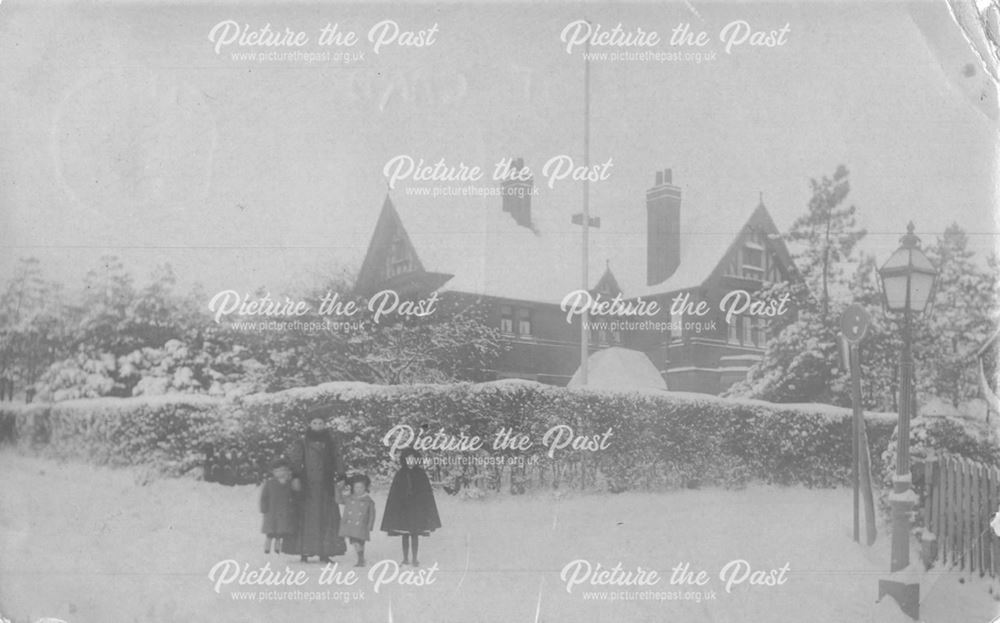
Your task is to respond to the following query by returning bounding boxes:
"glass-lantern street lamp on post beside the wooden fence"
[878,222,937,618]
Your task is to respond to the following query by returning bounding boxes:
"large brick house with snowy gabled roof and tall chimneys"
[357,163,798,394]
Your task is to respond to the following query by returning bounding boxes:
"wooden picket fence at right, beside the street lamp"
[923,455,1000,578]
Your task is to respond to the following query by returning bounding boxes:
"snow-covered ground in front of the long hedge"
[0,450,1000,623]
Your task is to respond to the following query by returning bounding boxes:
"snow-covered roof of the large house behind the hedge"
[359,182,792,303]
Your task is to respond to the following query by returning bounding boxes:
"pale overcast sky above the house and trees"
[0,0,998,292]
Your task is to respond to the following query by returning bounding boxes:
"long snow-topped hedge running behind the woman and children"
[0,381,916,490]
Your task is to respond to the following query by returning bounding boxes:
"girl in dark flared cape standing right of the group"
[382,448,441,567]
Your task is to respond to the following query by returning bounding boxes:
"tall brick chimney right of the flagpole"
[646,169,681,286]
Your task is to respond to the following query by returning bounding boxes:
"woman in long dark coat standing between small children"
[285,411,347,562]
